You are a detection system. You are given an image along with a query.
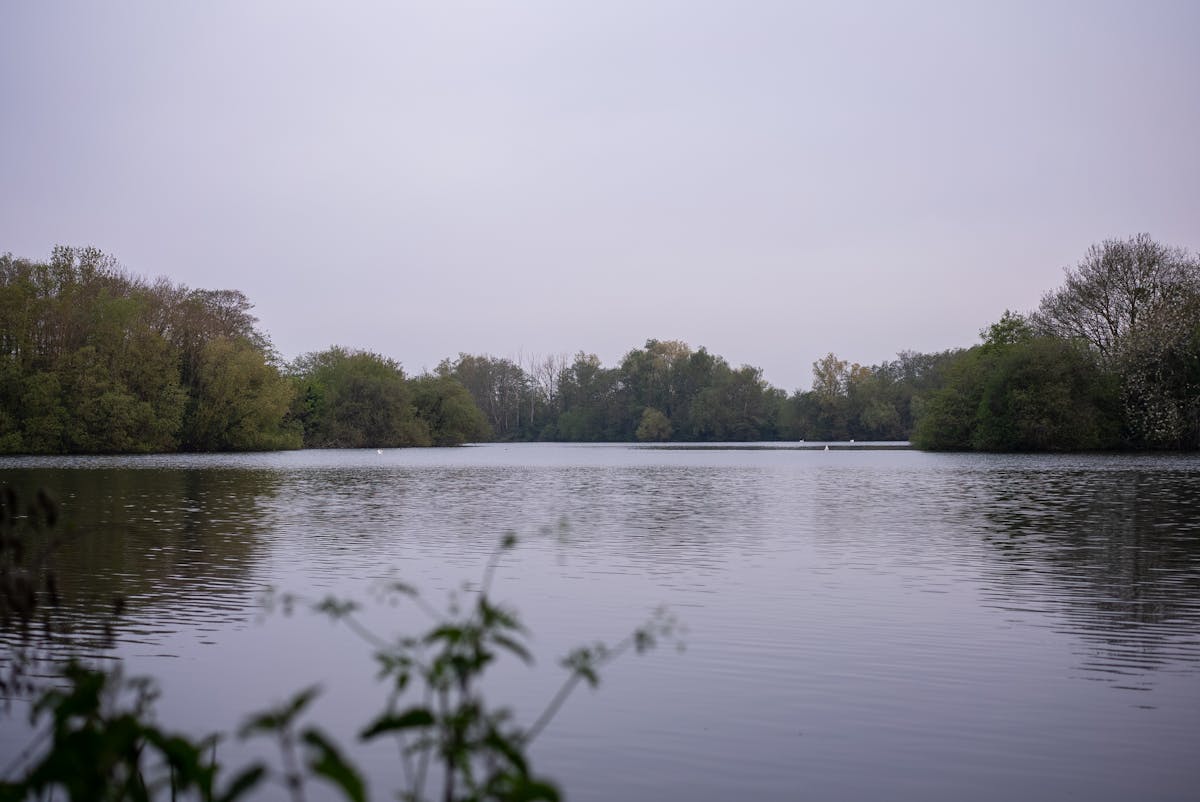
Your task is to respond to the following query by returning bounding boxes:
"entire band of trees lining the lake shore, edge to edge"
[0,234,1200,453]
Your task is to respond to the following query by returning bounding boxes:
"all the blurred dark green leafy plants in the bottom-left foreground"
[0,492,679,802]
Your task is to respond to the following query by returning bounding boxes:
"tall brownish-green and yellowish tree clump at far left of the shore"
[0,246,298,453]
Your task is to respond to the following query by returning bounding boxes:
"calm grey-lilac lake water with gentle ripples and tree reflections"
[0,444,1200,802]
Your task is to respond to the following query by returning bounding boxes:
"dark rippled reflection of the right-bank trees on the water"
[977,468,1200,682]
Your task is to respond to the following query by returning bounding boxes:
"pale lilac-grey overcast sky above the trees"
[0,0,1200,390]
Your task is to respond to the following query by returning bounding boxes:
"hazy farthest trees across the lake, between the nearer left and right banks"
[437,340,959,442]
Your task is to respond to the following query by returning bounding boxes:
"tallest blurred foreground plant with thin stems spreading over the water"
[256,533,678,802]
